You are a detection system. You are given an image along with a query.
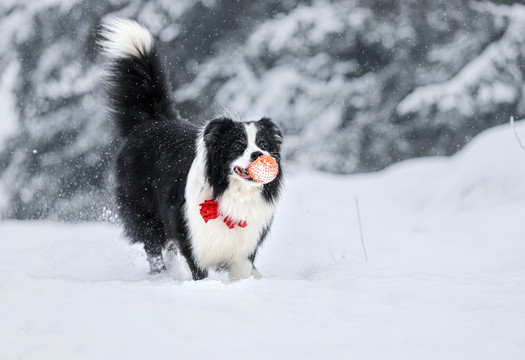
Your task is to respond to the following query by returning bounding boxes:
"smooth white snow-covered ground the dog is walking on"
[0,123,525,360]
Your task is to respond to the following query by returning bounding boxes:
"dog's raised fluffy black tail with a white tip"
[100,17,179,136]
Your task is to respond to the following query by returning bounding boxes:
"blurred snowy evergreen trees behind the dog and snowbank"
[0,0,525,221]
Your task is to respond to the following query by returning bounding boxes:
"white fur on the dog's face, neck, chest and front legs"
[185,124,275,279]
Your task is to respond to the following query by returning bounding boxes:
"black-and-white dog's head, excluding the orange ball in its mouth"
[203,117,283,200]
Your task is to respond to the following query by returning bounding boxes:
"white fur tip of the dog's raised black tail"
[100,17,154,59]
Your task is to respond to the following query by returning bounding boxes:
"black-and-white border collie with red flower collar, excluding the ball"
[100,18,283,280]
